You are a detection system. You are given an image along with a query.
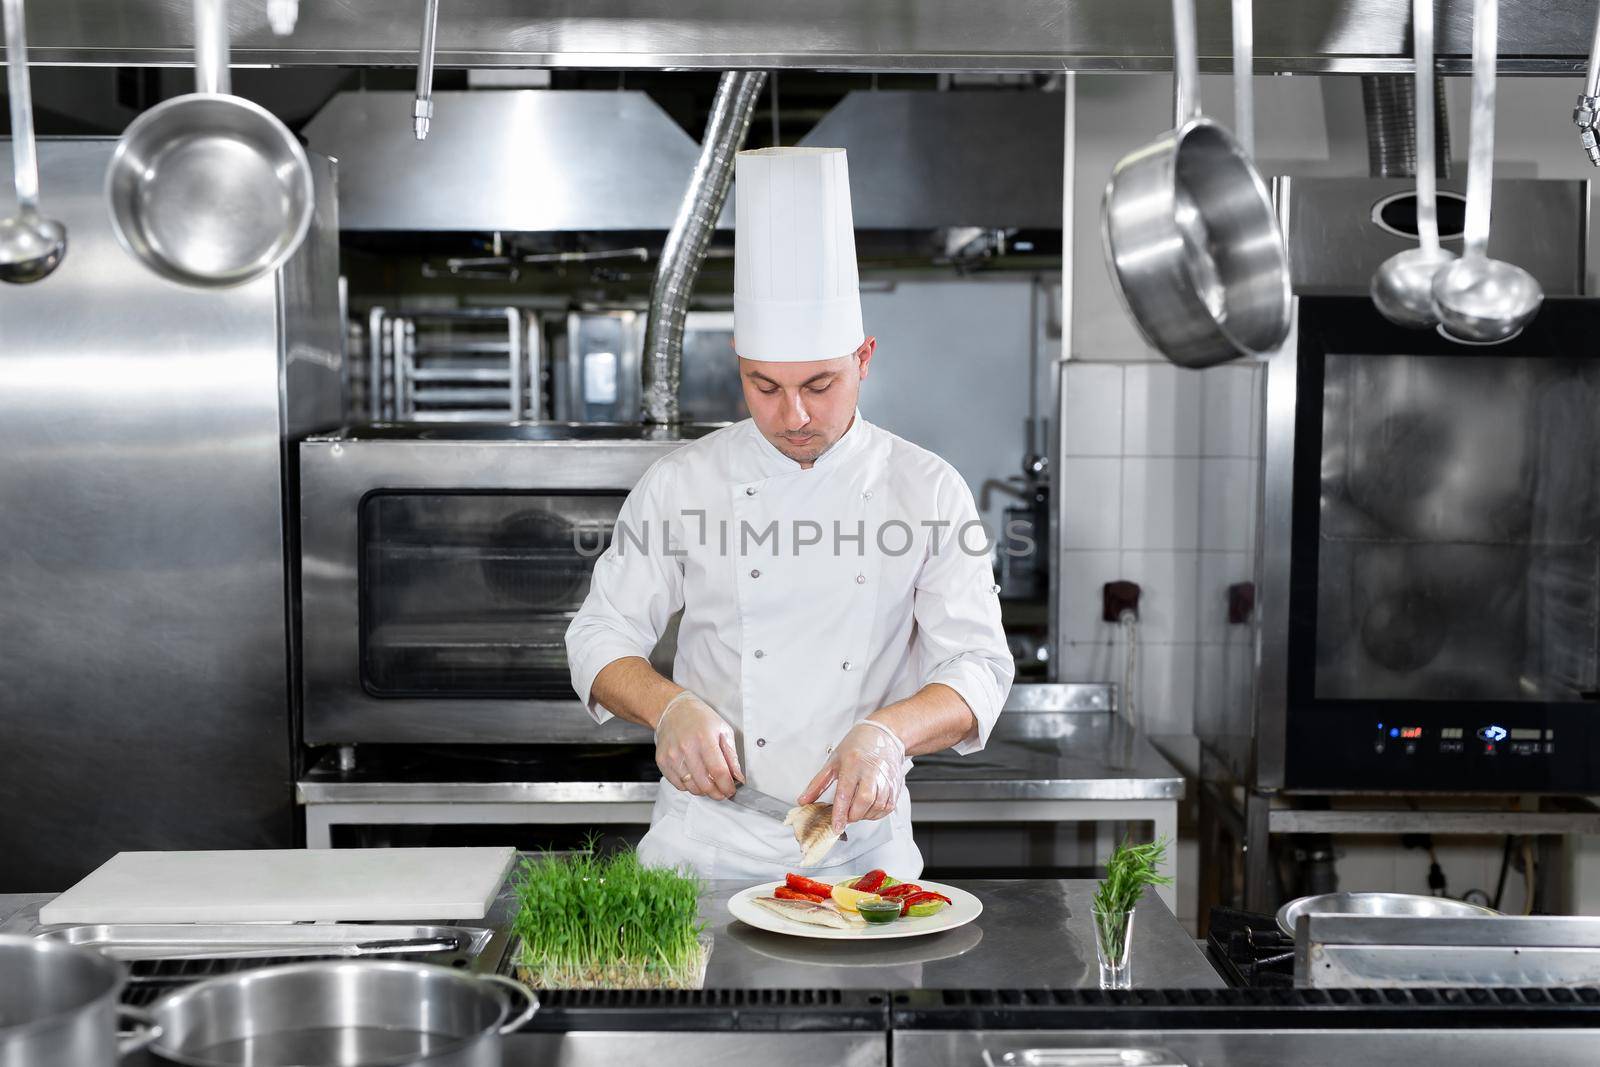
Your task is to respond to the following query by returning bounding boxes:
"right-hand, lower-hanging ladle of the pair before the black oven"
[1418,0,1544,344]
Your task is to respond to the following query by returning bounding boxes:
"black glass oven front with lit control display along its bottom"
[1283,298,1600,793]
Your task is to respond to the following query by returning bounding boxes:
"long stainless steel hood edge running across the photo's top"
[12,0,1595,74]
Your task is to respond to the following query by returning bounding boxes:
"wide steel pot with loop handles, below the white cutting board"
[150,961,539,1067]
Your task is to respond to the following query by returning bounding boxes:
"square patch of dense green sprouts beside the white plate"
[512,851,707,989]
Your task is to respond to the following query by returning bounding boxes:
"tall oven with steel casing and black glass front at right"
[1222,179,1600,793]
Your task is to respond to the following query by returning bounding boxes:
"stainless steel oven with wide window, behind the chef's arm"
[299,424,710,745]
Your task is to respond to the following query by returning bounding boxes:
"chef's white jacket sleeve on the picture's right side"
[912,472,1016,755]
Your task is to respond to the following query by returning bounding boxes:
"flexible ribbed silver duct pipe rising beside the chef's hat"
[640,70,766,426]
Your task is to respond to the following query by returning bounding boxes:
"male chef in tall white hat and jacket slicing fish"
[566,149,1014,881]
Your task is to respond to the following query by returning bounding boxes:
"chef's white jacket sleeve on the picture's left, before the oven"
[566,464,683,723]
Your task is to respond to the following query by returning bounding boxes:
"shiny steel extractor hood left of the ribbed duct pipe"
[304,90,733,230]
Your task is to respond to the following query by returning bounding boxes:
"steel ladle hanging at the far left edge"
[0,0,67,285]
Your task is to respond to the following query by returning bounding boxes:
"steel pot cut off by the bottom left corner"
[0,936,160,1067]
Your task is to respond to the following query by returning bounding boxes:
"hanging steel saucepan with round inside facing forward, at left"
[106,0,312,288]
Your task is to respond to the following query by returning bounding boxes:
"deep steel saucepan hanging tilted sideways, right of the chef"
[1101,0,1290,368]
